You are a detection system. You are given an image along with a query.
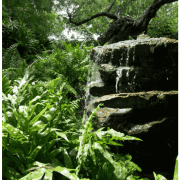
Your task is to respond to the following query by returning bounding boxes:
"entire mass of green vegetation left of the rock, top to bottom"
[2,0,176,180]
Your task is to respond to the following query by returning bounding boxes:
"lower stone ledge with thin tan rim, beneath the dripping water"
[86,91,178,112]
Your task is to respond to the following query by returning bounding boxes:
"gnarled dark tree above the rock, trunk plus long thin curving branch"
[67,0,176,45]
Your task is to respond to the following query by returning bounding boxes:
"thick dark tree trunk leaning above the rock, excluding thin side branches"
[98,0,175,46]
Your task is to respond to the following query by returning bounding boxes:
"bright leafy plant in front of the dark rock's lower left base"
[76,105,141,179]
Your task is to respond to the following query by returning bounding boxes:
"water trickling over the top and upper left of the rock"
[85,35,176,122]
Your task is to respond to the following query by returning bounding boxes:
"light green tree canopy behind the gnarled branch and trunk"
[56,0,178,43]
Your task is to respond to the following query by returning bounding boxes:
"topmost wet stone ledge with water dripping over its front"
[90,38,178,68]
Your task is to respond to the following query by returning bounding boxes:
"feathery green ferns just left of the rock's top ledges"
[24,42,92,105]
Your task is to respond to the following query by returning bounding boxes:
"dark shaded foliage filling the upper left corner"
[2,0,59,65]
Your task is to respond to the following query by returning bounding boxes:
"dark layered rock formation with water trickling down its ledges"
[85,35,178,179]
